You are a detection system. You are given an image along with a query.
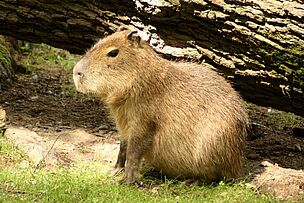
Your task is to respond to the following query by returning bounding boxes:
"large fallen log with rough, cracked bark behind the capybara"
[0,0,304,116]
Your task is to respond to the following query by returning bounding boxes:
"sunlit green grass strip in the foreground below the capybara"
[0,137,276,202]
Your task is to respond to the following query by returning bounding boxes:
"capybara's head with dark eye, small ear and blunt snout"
[73,27,150,98]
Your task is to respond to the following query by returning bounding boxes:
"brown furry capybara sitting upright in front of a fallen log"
[74,28,248,183]
